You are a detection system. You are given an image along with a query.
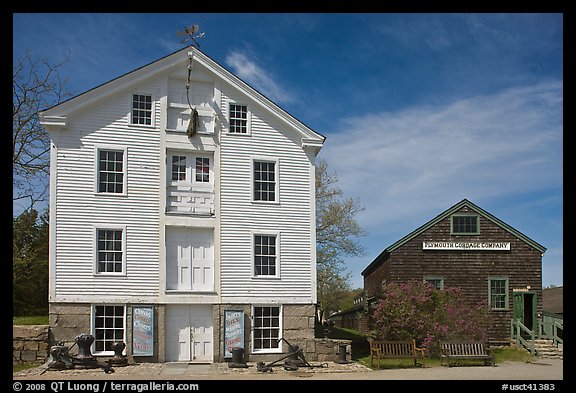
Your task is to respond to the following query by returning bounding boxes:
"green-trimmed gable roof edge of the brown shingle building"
[361,199,546,275]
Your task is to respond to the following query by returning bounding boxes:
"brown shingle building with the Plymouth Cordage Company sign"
[356,199,546,343]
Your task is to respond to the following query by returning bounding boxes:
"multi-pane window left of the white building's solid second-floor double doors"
[96,229,124,273]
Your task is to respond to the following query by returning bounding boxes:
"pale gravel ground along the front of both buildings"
[13,359,563,380]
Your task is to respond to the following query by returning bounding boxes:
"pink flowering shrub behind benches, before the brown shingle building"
[372,281,490,354]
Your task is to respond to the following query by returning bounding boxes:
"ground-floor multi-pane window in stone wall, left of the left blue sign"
[94,306,125,352]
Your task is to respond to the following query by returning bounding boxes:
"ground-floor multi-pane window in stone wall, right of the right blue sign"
[253,306,281,352]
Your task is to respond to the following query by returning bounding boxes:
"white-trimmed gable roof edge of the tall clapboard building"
[40,46,326,148]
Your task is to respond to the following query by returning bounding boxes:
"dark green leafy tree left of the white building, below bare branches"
[12,209,48,316]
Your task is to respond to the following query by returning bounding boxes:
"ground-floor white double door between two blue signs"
[166,304,213,363]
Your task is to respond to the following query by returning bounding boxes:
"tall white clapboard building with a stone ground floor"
[41,47,325,362]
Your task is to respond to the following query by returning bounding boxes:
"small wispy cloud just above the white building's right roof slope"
[225,51,293,103]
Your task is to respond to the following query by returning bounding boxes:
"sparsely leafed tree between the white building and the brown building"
[316,160,366,322]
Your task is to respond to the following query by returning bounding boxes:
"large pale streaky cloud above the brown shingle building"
[320,81,563,233]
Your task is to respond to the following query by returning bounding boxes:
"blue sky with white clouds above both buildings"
[13,13,563,287]
